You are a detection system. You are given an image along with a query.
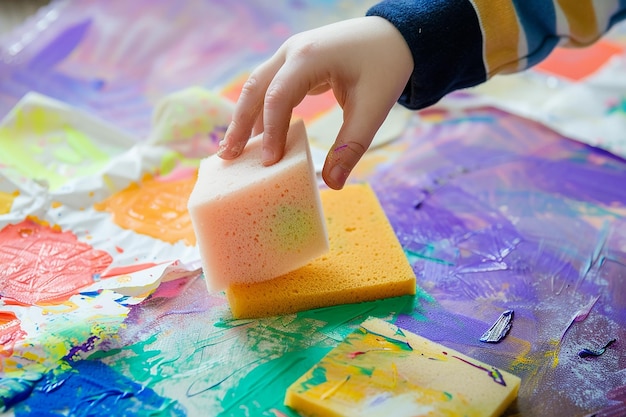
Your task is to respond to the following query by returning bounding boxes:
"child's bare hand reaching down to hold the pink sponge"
[218,17,413,189]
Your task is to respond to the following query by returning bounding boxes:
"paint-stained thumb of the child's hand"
[322,100,391,190]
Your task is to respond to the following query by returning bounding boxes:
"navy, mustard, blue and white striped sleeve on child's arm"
[367,0,626,109]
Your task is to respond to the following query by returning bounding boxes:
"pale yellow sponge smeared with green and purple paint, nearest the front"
[285,318,521,417]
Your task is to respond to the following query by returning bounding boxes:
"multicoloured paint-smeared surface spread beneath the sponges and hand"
[0,0,626,417]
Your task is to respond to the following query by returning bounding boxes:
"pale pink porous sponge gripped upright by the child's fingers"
[188,121,328,291]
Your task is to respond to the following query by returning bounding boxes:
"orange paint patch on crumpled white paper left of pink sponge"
[94,170,196,246]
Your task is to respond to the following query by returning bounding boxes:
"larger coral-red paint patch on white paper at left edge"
[0,217,113,305]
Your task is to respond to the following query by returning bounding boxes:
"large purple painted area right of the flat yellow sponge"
[371,110,626,415]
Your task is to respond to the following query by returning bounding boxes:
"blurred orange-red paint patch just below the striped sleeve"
[534,40,624,81]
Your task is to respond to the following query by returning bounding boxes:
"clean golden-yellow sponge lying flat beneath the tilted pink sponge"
[226,184,415,318]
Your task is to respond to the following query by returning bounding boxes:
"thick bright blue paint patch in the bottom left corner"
[13,360,186,417]
